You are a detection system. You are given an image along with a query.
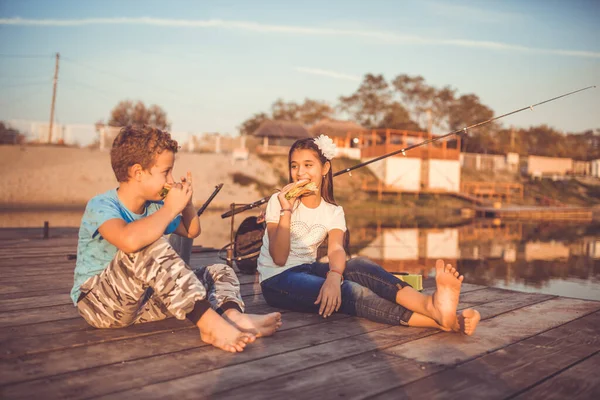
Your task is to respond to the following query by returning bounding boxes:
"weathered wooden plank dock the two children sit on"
[0,229,600,399]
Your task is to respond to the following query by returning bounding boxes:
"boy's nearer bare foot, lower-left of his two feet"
[197,309,256,353]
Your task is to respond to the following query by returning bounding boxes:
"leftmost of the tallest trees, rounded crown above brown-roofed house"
[340,74,392,128]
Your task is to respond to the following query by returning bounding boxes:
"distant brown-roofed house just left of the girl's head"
[252,120,313,154]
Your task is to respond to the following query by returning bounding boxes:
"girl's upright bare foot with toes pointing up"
[433,260,464,330]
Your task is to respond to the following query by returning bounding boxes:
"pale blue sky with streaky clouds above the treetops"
[0,0,600,144]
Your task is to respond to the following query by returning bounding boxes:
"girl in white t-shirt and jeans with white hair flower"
[257,135,480,335]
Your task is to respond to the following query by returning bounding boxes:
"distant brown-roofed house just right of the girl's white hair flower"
[308,118,368,159]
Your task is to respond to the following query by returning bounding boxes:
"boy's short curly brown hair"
[110,125,179,182]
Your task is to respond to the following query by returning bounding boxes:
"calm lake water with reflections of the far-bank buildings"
[0,211,600,300]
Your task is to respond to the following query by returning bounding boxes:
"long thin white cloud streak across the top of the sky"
[0,17,600,58]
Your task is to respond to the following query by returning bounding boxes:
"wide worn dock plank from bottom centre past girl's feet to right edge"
[207,299,598,399]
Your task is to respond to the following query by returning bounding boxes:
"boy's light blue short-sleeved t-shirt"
[71,189,181,304]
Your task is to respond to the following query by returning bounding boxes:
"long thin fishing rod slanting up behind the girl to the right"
[221,85,596,219]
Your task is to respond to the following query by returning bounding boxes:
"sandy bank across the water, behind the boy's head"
[0,146,278,208]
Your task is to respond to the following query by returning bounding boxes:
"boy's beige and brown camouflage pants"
[77,238,244,328]
